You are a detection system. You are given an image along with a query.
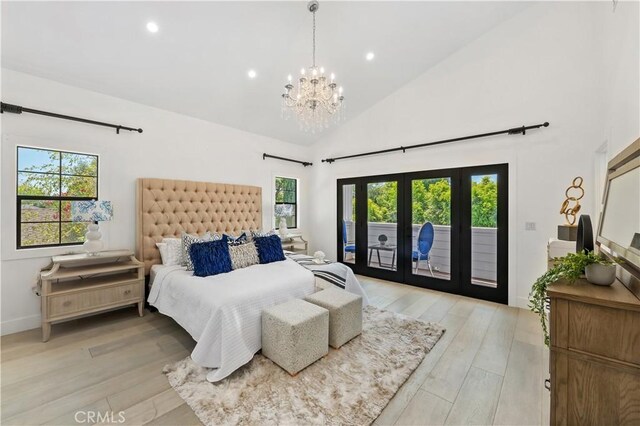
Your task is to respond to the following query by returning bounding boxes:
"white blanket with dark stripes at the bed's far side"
[287,253,369,307]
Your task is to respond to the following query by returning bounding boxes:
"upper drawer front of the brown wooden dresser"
[568,301,640,366]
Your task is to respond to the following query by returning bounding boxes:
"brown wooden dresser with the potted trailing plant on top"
[547,280,640,426]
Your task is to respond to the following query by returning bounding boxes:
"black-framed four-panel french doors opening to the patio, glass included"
[337,164,508,303]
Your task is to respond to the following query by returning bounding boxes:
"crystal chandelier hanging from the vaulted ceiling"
[282,0,344,133]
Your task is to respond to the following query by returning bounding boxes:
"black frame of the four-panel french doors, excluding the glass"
[336,164,509,304]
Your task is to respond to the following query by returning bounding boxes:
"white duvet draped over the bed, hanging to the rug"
[148,259,318,382]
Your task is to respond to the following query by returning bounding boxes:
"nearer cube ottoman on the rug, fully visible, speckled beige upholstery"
[262,299,329,375]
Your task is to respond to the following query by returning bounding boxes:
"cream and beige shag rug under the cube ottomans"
[164,306,444,425]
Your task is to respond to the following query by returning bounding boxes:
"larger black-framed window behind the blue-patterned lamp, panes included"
[16,146,98,249]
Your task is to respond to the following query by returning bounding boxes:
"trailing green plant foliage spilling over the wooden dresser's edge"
[529,251,615,346]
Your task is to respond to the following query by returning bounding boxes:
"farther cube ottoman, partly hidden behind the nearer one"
[304,288,362,349]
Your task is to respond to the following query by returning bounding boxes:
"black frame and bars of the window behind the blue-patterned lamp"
[16,145,100,250]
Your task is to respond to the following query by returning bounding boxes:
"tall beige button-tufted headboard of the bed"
[136,178,262,274]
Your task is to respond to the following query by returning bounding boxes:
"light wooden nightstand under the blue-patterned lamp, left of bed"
[39,250,144,342]
